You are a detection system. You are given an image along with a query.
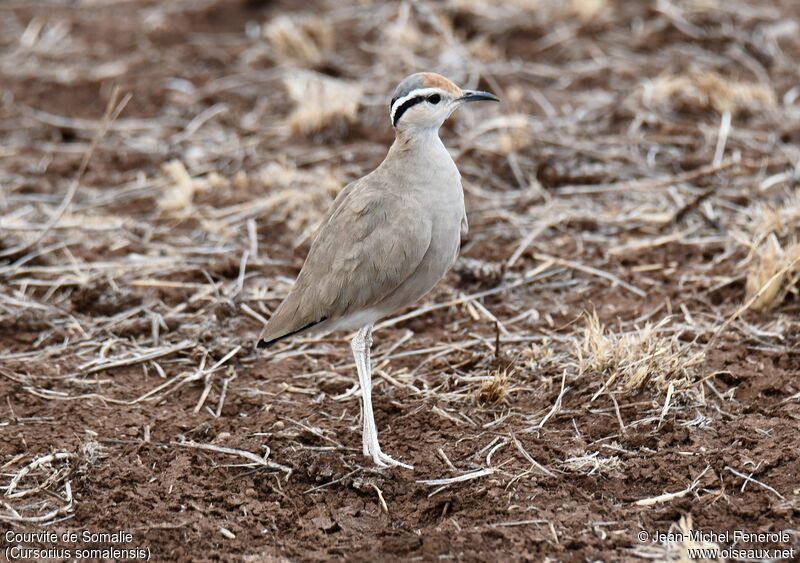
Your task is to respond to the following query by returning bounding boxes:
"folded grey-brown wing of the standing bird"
[261,176,432,341]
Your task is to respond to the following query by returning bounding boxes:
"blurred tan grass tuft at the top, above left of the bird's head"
[264,16,335,67]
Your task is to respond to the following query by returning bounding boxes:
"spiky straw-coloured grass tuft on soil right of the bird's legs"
[578,313,702,393]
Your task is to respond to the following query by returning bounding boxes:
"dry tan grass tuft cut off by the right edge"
[745,236,800,311]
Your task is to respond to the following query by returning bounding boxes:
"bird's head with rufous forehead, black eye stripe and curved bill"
[389,72,500,131]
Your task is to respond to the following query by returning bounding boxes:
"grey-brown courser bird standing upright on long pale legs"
[257,72,500,469]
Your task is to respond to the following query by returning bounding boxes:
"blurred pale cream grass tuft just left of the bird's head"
[284,72,363,135]
